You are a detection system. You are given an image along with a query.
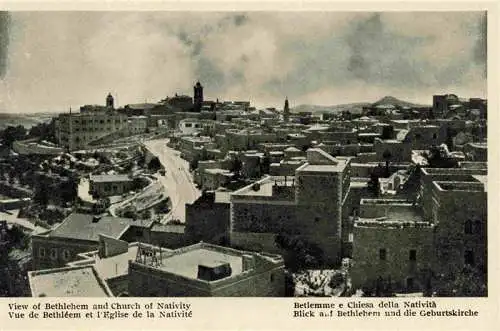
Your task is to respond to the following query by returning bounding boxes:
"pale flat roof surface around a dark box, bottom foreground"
[159,247,243,279]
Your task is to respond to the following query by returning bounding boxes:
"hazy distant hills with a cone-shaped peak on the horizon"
[291,96,429,113]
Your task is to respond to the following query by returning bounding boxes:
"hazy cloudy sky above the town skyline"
[0,12,487,112]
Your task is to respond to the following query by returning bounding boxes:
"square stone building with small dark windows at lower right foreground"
[350,199,434,295]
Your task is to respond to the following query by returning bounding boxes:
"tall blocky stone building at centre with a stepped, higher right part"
[230,149,350,264]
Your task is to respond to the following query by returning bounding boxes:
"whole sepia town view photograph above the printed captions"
[0,10,488,300]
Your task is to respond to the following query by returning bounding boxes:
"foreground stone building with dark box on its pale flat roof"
[128,243,285,297]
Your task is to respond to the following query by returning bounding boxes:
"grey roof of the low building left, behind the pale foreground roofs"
[48,213,146,242]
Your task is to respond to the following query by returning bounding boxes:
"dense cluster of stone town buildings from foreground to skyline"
[0,82,488,296]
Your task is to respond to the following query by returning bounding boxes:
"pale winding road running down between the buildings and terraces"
[144,139,201,223]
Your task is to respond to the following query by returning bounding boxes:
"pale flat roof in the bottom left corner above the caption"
[28,266,111,298]
